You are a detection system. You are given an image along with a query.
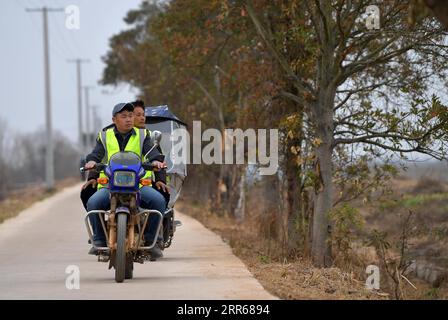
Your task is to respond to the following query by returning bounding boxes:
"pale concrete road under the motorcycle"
[0,185,275,299]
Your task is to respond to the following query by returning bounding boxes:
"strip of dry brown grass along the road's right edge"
[177,200,388,300]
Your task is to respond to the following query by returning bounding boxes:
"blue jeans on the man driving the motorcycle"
[87,186,166,243]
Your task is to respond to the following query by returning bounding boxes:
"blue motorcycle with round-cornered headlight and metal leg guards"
[80,131,171,283]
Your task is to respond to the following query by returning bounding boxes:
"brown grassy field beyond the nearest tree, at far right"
[356,177,448,299]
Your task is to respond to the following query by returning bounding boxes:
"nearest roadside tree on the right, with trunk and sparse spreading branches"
[244,0,448,266]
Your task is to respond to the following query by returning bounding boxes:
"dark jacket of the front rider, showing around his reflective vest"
[86,125,166,183]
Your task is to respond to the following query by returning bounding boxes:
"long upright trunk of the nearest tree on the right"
[311,0,338,267]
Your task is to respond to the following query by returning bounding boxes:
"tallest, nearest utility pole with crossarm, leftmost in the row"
[26,7,64,190]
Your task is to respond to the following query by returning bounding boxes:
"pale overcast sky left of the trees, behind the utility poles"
[0,0,141,142]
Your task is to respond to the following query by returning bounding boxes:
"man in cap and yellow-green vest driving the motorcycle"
[84,103,166,258]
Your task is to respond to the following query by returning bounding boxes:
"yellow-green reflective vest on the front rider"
[98,128,153,190]
